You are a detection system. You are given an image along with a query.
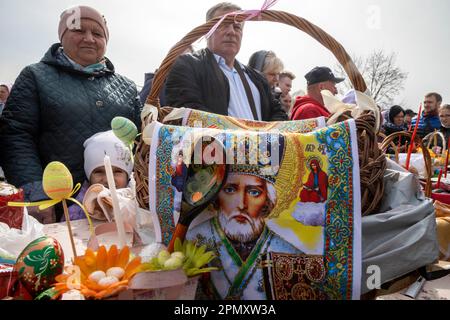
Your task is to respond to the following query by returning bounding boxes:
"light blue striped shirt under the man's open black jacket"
[214,54,262,120]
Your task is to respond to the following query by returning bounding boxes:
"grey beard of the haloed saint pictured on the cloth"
[219,212,265,243]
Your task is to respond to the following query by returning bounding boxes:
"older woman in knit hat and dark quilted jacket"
[0,6,141,222]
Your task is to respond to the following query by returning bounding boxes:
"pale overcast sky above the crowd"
[0,0,450,110]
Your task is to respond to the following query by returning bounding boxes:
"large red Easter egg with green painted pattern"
[14,236,64,297]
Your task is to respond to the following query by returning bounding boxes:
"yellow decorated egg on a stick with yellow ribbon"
[42,161,73,200]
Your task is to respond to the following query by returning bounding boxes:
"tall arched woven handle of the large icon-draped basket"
[146,10,367,109]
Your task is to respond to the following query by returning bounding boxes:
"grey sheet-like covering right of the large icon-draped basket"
[361,160,439,294]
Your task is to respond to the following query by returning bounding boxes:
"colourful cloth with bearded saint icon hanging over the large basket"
[149,120,361,300]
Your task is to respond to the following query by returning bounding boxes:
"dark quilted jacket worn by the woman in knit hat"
[0,44,141,201]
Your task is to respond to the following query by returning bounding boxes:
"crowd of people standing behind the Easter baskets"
[0,2,444,222]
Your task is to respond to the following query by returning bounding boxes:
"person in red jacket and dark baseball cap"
[291,67,344,120]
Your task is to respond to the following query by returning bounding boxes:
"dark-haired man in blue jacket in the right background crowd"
[411,92,442,138]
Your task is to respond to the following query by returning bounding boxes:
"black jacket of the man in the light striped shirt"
[166,49,287,121]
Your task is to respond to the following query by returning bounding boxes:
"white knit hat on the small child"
[83,130,133,179]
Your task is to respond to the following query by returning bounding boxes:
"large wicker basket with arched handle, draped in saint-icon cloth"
[134,10,386,214]
